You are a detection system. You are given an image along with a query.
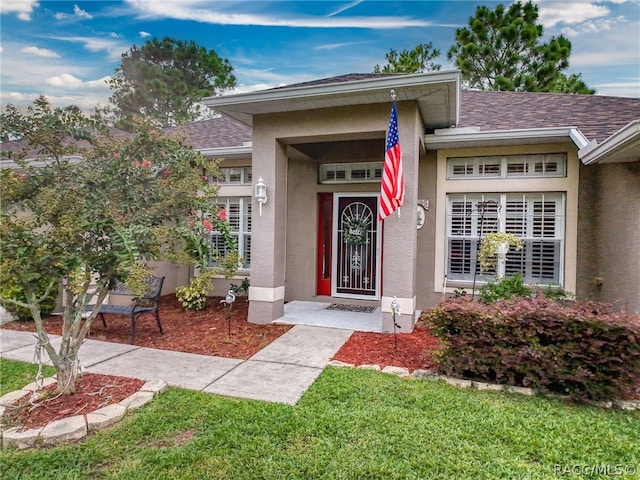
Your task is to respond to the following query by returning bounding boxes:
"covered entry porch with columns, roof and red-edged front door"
[202,73,457,332]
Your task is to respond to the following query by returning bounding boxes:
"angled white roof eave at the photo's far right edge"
[578,119,640,165]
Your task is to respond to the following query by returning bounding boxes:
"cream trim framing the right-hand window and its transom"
[434,143,579,293]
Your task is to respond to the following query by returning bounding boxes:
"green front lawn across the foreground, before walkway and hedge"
[0,361,640,480]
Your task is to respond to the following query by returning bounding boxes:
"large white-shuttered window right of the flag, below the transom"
[446,193,564,285]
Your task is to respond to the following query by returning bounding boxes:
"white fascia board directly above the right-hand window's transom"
[424,126,589,150]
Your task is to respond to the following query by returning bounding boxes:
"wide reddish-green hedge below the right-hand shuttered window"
[426,296,640,400]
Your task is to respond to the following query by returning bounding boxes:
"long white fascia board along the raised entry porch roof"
[202,70,459,110]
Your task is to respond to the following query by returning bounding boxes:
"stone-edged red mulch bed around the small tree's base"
[3,373,145,430]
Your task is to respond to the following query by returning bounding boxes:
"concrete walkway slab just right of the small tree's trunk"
[85,347,243,390]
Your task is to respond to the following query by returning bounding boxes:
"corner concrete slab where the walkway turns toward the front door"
[203,360,322,405]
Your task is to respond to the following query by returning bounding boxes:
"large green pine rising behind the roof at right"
[447,1,595,93]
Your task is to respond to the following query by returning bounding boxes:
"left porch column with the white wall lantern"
[248,133,287,323]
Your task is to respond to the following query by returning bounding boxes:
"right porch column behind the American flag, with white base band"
[381,103,424,333]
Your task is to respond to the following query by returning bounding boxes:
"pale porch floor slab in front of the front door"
[273,300,382,332]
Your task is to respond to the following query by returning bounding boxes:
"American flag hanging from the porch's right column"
[378,102,404,220]
